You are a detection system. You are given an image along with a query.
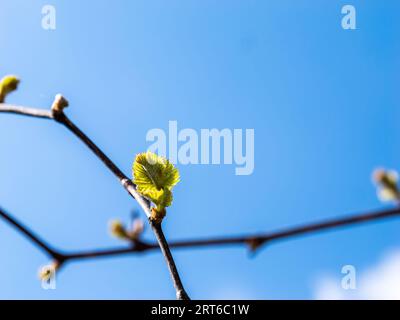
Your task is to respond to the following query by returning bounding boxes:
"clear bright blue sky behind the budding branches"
[0,0,400,299]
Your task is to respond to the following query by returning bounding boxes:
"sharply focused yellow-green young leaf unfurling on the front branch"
[133,152,180,211]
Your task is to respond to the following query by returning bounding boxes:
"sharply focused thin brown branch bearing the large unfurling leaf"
[0,104,189,299]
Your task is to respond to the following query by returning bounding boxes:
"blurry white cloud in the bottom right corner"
[314,250,400,300]
